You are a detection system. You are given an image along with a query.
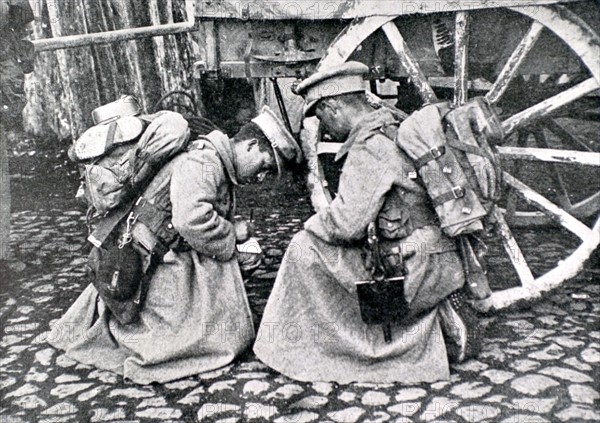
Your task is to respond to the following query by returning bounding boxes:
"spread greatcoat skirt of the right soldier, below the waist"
[254,231,464,384]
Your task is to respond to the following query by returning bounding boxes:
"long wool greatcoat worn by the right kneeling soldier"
[254,110,464,383]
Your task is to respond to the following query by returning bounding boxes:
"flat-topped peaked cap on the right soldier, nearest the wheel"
[295,61,369,117]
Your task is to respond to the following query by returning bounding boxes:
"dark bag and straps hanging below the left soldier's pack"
[88,157,187,324]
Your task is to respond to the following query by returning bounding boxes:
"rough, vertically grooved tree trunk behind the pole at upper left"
[24,0,200,138]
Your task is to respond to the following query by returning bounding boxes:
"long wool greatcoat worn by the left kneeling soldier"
[48,132,254,384]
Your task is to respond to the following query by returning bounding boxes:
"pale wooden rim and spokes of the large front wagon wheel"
[305,5,600,308]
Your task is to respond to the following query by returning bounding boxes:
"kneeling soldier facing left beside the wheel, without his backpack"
[254,62,479,383]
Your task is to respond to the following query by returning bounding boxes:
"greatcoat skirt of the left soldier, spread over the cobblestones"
[48,251,254,384]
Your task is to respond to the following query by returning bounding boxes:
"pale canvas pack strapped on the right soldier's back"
[382,98,504,299]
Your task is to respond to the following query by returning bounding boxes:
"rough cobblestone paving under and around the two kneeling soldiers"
[0,151,600,423]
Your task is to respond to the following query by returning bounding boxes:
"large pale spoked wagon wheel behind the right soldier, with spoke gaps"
[305,6,600,308]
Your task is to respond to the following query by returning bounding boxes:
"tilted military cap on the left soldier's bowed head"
[252,106,302,174]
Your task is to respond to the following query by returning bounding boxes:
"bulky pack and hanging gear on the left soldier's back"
[69,97,189,324]
